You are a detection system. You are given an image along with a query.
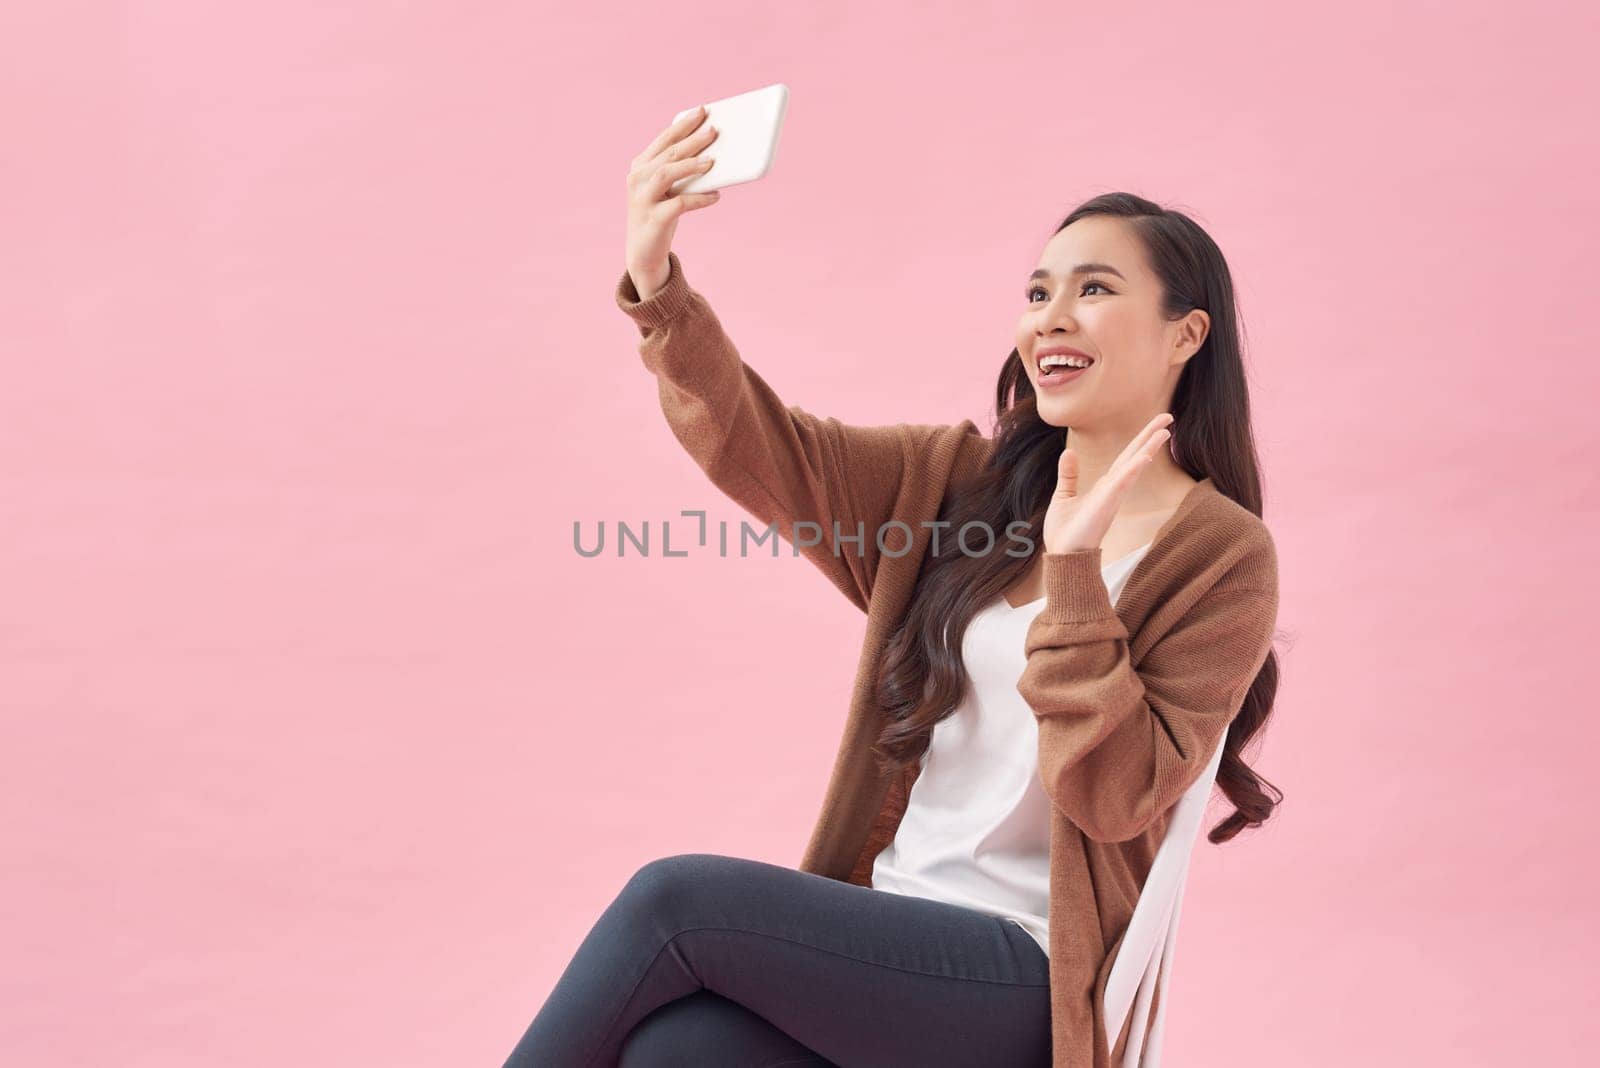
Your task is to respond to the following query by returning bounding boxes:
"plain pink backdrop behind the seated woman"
[0,0,1600,1068]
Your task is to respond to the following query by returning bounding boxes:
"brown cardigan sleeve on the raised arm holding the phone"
[616,253,938,611]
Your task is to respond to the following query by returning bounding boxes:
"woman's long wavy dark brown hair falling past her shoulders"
[874,193,1283,843]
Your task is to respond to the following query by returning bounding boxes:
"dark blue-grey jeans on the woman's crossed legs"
[506,854,1050,1068]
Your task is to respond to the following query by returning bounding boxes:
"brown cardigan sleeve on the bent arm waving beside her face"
[1018,537,1278,843]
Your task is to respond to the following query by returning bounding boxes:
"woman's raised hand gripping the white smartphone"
[627,107,720,301]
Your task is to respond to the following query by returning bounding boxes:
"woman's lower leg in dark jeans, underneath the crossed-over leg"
[619,990,837,1068]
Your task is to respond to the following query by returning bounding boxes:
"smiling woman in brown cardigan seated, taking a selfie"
[506,112,1282,1068]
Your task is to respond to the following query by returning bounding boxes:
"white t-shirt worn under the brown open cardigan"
[872,542,1154,956]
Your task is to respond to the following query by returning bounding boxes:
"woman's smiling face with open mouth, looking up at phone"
[1016,216,1210,432]
